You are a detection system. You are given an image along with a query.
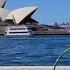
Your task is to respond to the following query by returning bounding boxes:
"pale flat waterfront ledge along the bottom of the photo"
[0,66,70,70]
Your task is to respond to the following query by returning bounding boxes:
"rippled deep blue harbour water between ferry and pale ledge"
[0,35,70,66]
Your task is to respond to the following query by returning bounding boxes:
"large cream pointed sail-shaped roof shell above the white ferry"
[6,7,37,24]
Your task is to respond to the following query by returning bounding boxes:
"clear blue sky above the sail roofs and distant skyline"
[5,0,70,24]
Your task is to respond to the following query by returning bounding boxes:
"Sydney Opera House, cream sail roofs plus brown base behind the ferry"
[0,0,41,34]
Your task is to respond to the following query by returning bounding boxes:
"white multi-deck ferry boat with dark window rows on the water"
[5,25,31,36]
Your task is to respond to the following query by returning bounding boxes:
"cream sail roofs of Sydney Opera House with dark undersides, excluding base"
[0,0,37,24]
